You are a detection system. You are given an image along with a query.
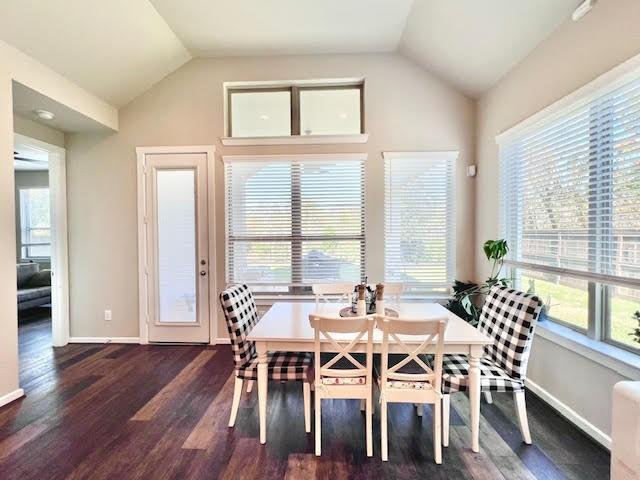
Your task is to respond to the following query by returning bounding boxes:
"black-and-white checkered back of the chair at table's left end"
[220,285,259,368]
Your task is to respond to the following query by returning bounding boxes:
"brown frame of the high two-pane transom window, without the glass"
[225,80,365,139]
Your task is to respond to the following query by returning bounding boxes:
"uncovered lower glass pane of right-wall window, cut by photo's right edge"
[609,286,640,348]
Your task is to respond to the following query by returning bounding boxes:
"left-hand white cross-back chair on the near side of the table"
[309,314,375,457]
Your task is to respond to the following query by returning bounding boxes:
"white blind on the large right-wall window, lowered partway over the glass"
[499,71,640,279]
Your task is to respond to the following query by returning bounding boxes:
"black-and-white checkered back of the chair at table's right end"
[478,286,542,379]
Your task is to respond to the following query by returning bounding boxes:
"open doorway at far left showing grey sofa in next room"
[14,134,69,364]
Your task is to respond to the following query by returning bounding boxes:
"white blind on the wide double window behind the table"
[224,154,365,287]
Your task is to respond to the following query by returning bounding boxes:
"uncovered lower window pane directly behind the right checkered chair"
[516,270,589,330]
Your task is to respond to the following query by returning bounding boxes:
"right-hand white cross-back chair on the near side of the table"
[377,316,447,463]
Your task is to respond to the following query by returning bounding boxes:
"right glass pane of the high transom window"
[300,88,361,135]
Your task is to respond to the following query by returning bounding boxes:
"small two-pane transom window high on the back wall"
[227,82,364,137]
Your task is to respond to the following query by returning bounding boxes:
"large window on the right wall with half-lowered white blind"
[499,67,640,349]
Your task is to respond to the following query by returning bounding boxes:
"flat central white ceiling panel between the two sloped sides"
[150,0,413,56]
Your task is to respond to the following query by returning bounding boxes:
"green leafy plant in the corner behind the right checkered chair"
[445,239,509,326]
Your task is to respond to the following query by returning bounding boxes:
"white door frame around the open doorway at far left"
[13,133,69,347]
